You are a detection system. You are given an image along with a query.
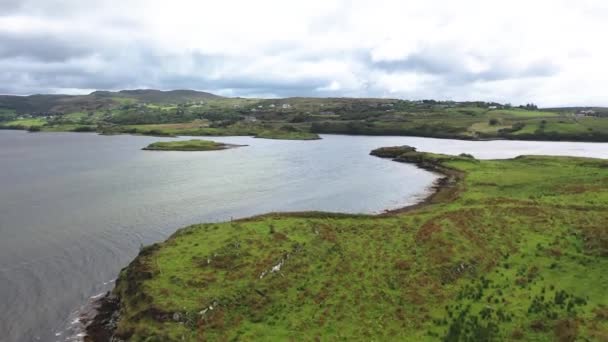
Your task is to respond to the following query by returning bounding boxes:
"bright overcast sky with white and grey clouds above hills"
[0,0,608,107]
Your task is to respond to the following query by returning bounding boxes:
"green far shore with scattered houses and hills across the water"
[0,89,608,142]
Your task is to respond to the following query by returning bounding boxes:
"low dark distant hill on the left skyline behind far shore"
[0,89,221,113]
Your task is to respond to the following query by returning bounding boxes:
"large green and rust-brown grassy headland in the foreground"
[89,147,608,341]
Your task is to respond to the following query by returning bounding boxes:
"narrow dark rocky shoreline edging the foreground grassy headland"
[80,147,464,342]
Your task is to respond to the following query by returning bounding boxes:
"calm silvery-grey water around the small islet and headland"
[0,131,608,341]
